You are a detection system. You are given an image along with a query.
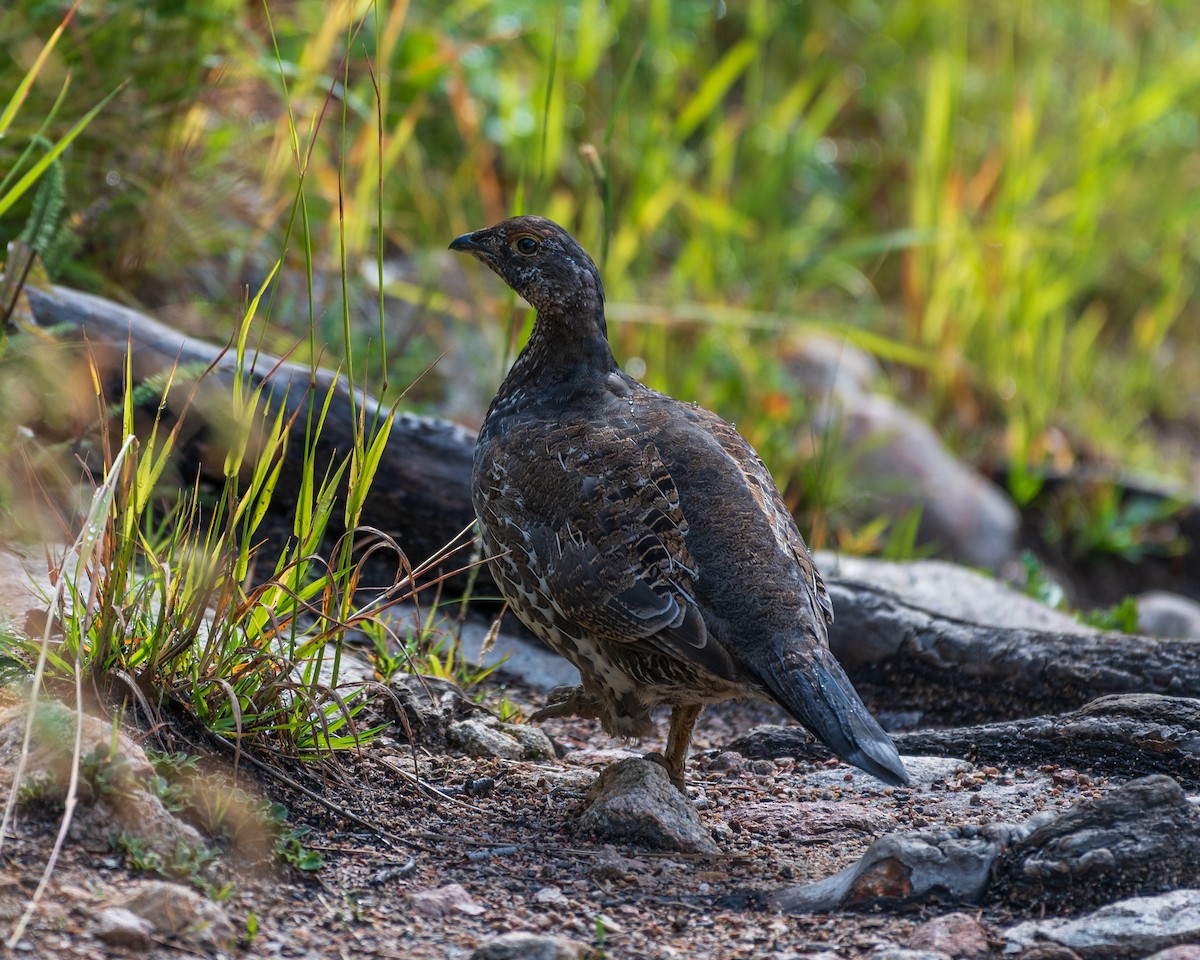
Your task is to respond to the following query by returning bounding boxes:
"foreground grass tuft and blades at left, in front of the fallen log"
[0,3,482,757]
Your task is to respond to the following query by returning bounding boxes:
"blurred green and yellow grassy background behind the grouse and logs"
[0,0,1200,546]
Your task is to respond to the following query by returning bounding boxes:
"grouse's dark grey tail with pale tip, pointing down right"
[757,646,908,786]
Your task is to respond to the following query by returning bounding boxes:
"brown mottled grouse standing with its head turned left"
[450,216,907,790]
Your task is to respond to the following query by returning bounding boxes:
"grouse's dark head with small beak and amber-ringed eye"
[450,216,604,313]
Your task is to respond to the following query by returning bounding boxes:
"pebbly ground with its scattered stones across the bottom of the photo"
[0,652,1200,960]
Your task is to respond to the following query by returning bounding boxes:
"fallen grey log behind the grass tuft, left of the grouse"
[16,280,486,581]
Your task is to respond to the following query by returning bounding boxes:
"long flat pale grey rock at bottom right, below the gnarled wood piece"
[1002,889,1200,960]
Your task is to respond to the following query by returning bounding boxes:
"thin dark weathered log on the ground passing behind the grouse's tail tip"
[725,694,1200,788]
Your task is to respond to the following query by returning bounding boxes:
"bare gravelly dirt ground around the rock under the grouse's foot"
[0,688,1108,960]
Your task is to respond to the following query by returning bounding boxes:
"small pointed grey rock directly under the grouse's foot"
[577,757,720,853]
